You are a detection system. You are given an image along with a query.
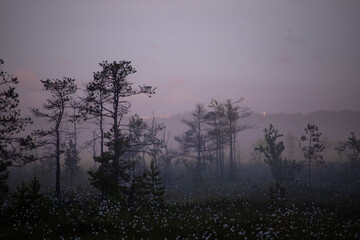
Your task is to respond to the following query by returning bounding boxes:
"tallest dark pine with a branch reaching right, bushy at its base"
[85,61,154,199]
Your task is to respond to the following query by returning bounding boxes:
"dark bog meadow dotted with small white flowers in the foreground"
[0,182,360,239]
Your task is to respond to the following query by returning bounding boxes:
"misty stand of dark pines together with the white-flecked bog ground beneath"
[0,60,360,239]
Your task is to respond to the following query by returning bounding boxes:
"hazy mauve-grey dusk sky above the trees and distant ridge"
[0,0,360,116]
